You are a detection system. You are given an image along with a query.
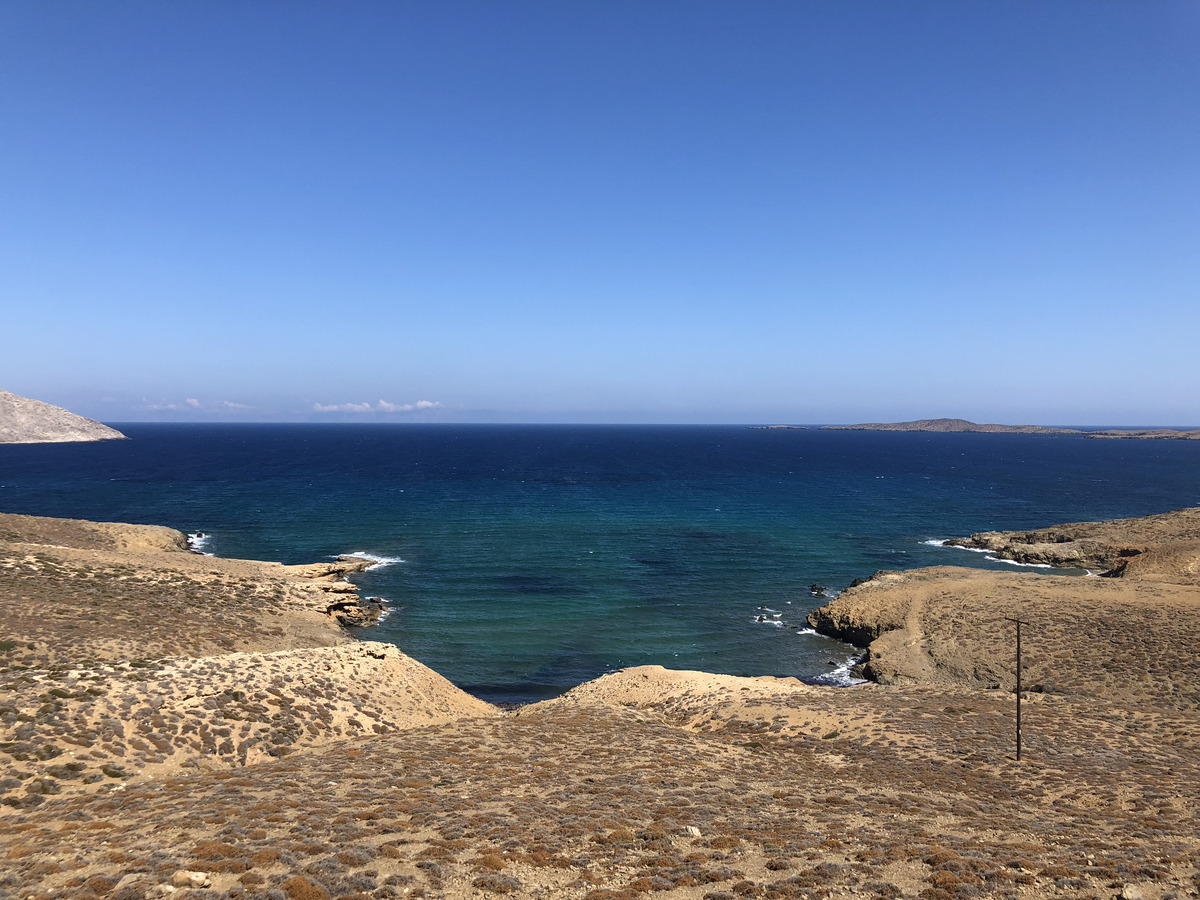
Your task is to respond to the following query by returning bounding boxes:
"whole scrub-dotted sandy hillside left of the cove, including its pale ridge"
[0,515,497,809]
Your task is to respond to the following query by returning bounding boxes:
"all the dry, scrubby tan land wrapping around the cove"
[0,516,1200,900]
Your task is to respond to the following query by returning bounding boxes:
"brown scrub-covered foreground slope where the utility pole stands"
[7,670,1200,900]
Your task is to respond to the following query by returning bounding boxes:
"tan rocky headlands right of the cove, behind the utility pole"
[808,508,1200,706]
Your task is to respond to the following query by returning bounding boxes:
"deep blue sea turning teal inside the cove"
[0,424,1200,702]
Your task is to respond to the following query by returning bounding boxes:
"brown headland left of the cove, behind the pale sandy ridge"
[0,514,400,666]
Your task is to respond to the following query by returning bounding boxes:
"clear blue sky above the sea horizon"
[0,0,1200,425]
